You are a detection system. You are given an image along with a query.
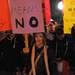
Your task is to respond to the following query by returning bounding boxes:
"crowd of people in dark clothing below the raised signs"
[0,21,75,75]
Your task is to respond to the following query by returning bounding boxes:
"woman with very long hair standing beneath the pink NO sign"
[30,33,57,75]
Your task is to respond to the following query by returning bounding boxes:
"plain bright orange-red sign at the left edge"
[0,0,11,31]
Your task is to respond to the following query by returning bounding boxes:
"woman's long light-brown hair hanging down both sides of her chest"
[29,34,50,75]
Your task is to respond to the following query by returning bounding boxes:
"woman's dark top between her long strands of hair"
[35,47,47,75]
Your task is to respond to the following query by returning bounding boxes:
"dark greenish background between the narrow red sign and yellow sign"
[50,0,63,25]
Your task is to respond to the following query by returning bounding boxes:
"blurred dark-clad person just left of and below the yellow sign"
[55,26,66,59]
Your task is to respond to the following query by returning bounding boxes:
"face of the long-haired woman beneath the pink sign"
[35,33,44,46]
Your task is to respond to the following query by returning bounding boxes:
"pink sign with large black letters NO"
[9,0,44,34]
